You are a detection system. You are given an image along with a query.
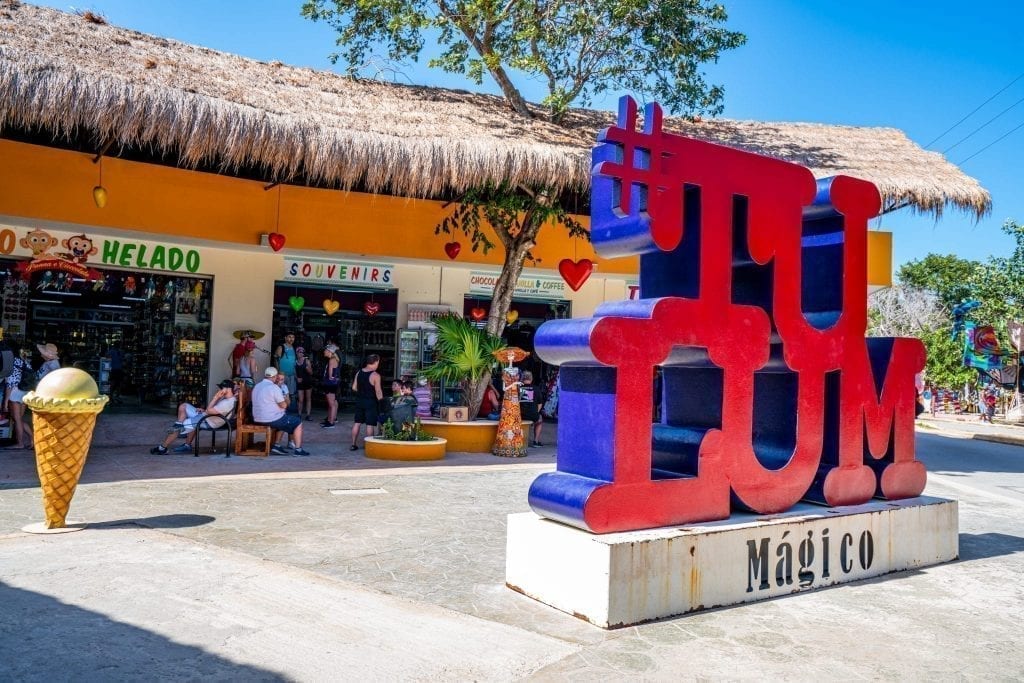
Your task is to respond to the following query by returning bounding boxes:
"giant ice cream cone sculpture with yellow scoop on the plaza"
[24,368,108,529]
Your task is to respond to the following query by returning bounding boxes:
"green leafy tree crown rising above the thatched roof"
[302,0,746,122]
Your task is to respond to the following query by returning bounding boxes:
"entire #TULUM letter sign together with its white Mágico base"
[506,98,958,628]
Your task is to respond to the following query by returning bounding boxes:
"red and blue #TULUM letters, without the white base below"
[529,98,926,532]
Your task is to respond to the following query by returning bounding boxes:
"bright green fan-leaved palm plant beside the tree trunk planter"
[423,313,506,415]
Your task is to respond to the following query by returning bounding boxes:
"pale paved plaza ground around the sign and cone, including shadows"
[0,412,1024,681]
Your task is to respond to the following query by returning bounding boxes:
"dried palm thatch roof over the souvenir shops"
[0,0,991,217]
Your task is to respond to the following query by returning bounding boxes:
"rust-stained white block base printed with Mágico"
[505,497,959,629]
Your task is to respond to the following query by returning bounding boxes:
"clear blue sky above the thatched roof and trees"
[32,0,1024,266]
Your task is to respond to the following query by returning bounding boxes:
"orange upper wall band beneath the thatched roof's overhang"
[0,140,638,274]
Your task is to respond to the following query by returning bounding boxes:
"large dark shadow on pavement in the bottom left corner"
[0,582,286,682]
